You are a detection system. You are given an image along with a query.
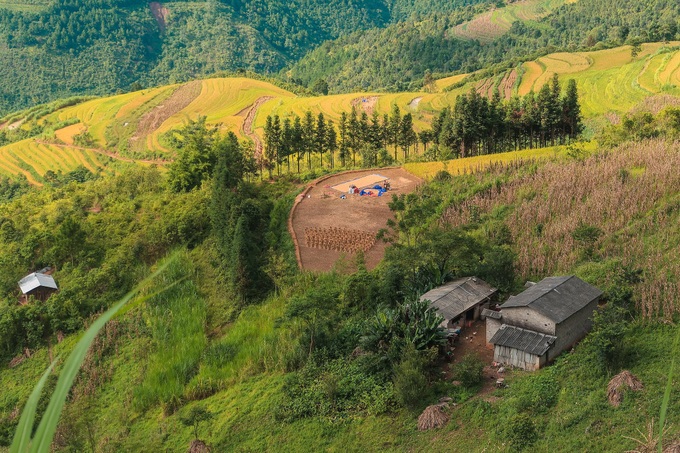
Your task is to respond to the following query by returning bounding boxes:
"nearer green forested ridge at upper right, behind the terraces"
[290,0,680,92]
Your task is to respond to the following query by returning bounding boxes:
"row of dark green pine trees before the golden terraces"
[258,75,583,176]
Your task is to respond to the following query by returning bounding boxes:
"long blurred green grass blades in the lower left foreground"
[10,253,177,453]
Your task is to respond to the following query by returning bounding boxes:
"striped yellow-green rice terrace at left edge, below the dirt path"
[0,139,106,185]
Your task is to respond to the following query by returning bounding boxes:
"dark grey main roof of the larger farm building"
[501,275,602,324]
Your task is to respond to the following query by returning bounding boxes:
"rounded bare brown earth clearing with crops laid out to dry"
[290,168,421,271]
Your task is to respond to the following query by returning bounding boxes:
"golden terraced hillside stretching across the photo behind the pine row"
[0,42,680,184]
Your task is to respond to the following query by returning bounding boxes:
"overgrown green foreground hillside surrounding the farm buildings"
[0,129,680,452]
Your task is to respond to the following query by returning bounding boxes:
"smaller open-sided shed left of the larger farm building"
[420,277,498,328]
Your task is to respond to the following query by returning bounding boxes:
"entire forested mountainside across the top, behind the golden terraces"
[0,0,678,113]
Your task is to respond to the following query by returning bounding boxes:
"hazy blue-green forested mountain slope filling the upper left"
[0,0,494,114]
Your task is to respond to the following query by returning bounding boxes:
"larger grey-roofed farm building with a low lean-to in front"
[482,276,602,370]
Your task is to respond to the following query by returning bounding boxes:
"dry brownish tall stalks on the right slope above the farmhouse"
[443,140,680,318]
